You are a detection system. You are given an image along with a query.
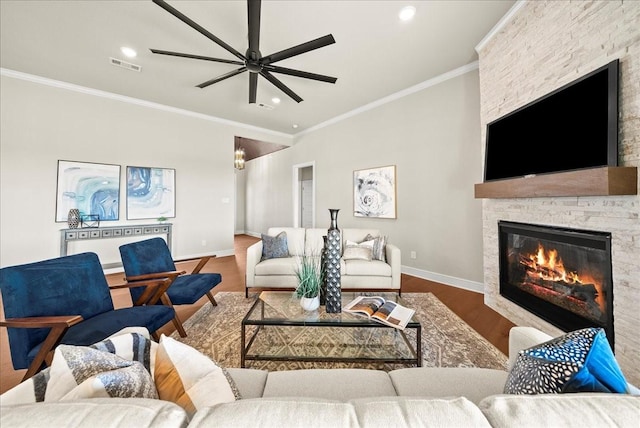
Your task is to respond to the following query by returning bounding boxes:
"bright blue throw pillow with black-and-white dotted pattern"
[504,328,628,394]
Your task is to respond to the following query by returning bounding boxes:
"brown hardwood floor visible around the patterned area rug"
[0,235,515,393]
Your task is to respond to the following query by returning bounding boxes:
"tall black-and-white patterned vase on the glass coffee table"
[325,209,342,313]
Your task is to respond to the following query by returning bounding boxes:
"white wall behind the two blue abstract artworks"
[0,75,288,266]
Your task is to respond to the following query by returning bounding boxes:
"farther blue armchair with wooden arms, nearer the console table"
[120,238,222,337]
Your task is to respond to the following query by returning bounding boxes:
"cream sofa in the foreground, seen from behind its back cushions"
[0,327,640,428]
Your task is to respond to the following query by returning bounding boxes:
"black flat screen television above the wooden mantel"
[484,59,619,181]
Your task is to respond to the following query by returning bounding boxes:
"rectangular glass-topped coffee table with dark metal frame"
[240,291,422,367]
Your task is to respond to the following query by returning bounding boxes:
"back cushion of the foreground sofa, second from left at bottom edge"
[189,398,359,428]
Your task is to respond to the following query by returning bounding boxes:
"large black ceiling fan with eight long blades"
[151,0,338,104]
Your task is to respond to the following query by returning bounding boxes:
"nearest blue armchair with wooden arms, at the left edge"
[0,253,175,379]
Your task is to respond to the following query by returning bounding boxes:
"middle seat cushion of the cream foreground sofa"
[263,369,396,401]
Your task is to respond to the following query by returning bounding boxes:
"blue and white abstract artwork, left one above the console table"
[56,160,120,222]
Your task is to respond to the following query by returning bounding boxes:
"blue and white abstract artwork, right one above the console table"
[127,166,176,220]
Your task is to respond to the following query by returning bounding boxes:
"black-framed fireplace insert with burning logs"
[498,221,614,348]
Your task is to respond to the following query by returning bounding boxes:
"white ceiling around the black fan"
[0,0,516,134]
